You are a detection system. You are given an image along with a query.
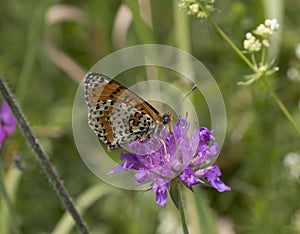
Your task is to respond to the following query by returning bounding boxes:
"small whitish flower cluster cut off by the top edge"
[178,0,215,18]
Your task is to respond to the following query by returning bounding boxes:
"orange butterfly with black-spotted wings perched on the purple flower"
[84,72,172,150]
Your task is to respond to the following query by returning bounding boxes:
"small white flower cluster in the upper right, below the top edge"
[244,19,279,52]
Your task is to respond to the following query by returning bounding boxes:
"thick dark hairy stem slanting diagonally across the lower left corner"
[0,77,89,234]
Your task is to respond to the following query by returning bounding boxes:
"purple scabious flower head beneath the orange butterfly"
[110,115,231,206]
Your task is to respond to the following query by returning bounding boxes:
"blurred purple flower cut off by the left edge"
[0,103,16,148]
